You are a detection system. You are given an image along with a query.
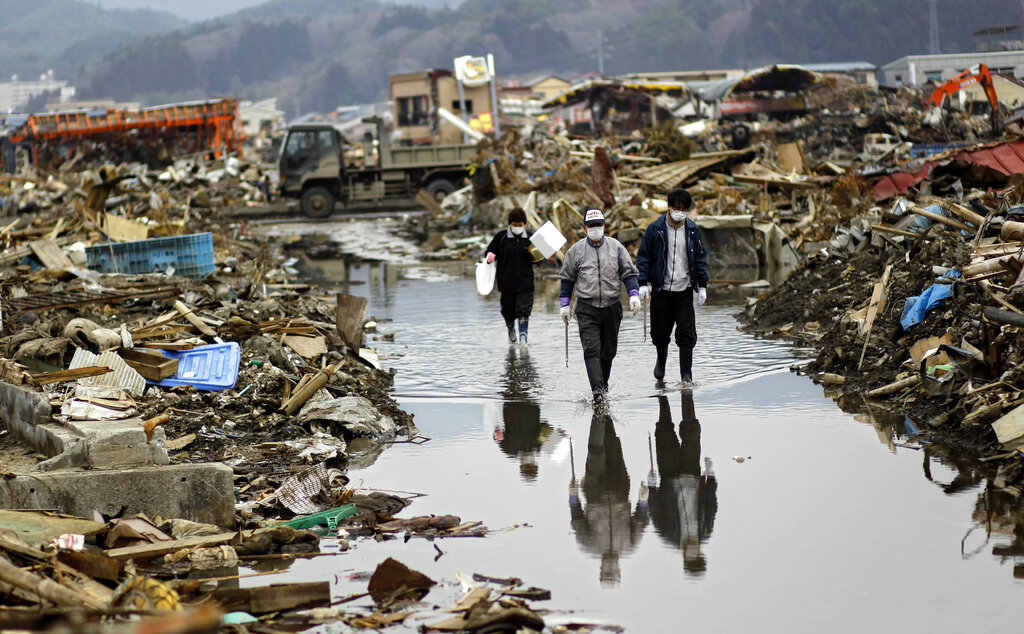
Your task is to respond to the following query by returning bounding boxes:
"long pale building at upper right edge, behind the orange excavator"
[882,50,1024,87]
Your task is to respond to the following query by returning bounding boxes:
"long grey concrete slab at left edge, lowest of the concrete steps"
[0,463,234,529]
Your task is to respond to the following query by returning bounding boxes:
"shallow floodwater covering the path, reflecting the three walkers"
[247,221,1024,632]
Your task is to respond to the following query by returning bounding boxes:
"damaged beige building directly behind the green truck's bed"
[388,70,494,145]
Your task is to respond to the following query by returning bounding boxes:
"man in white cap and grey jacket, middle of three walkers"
[558,209,640,405]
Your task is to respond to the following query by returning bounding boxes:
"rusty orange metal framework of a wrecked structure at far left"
[10,98,246,157]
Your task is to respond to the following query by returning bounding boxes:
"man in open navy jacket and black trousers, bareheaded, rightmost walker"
[637,188,708,383]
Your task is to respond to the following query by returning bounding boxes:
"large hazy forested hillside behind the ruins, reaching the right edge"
[59,0,1022,114]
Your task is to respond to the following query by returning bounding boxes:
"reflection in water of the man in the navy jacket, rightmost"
[650,390,718,576]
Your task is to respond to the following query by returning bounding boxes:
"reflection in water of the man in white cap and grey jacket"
[569,414,647,585]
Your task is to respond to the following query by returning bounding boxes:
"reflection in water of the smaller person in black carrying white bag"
[494,348,552,480]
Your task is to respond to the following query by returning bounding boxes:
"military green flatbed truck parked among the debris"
[278,117,476,218]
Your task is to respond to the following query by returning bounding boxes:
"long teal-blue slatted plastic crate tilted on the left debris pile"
[85,229,214,278]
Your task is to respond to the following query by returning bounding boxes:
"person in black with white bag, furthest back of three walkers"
[487,207,534,343]
